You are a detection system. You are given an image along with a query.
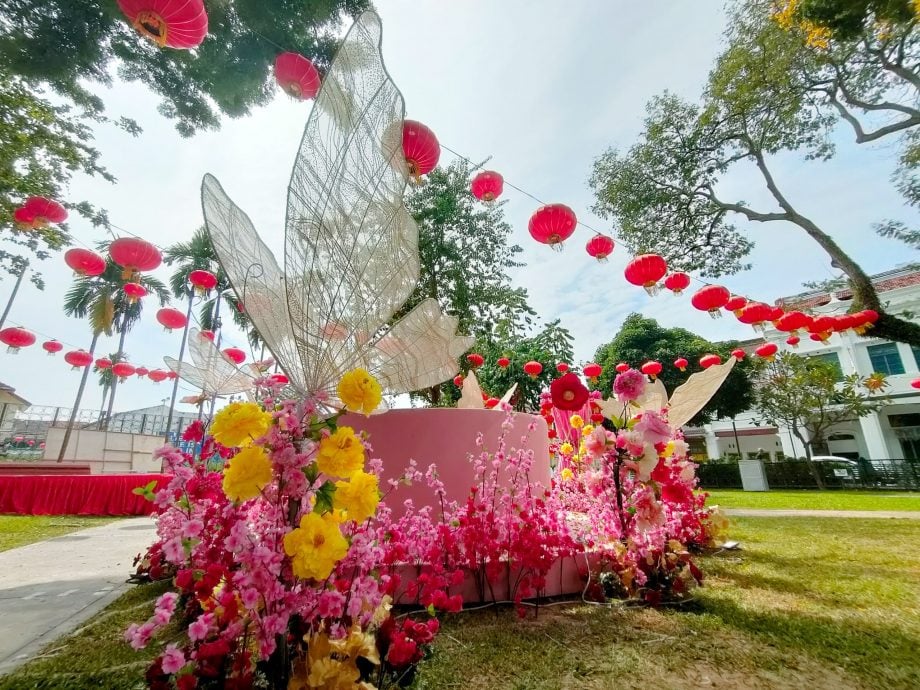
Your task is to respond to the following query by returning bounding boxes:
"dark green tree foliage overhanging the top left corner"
[0,0,369,135]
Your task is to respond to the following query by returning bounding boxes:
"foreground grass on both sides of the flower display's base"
[0,518,920,690]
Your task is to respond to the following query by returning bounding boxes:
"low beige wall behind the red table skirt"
[44,427,164,474]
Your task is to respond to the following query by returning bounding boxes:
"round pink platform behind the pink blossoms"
[339,408,583,602]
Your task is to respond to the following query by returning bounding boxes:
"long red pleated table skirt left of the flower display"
[0,474,170,515]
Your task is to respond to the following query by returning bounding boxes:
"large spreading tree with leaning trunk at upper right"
[591,0,920,345]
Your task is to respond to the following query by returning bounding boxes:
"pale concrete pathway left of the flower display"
[0,517,156,674]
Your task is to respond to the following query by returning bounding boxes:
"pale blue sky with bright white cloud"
[0,0,916,410]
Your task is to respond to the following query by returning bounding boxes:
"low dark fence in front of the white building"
[697,459,920,491]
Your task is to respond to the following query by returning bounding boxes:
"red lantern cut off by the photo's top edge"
[118,0,208,49]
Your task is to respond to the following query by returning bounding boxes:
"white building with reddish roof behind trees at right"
[685,269,920,460]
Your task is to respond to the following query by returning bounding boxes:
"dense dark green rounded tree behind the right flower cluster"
[594,314,754,426]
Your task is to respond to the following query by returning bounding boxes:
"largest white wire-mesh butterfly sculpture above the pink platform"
[193,12,472,409]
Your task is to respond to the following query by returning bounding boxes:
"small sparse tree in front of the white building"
[755,352,885,489]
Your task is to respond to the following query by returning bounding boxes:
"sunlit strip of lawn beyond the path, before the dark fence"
[707,489,920,511]
